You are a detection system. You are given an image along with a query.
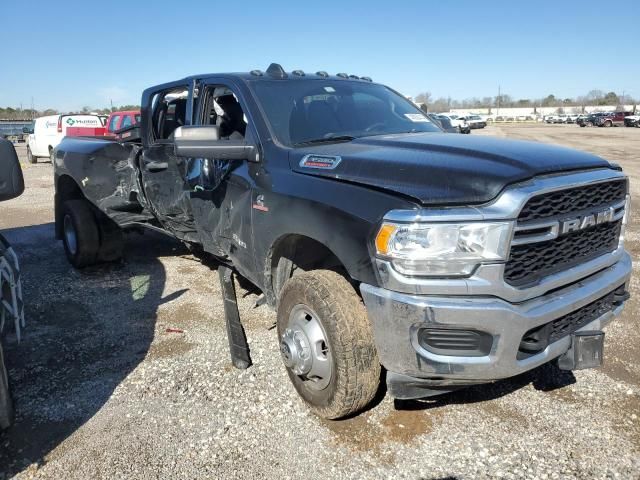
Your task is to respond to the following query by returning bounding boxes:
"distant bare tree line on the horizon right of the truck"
[415,90,637,112]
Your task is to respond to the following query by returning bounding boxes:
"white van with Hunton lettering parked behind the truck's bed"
[27,114,105,163]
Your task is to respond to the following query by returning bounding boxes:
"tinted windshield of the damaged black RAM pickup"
[252,80,441,146]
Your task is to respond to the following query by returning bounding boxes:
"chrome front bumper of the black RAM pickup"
[360,252,631,385]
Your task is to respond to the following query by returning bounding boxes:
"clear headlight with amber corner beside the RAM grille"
[375,222,511,277]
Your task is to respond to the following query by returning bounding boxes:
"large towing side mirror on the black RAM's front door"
[173,125,258,162]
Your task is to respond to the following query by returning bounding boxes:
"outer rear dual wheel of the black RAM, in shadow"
[62,200,100,268]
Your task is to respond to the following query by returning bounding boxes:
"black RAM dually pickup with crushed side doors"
[54,64,631,418]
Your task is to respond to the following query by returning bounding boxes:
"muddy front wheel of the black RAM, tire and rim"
[278,270,380,419]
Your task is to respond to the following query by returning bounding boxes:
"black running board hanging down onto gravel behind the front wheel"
[218,265,251,370]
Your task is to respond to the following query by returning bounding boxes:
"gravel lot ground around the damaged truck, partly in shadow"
[0,125,640,480]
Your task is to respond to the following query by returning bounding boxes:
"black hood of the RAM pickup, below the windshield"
[289,133,612,205]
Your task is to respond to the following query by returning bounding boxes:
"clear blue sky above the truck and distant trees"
[0,0,640,110]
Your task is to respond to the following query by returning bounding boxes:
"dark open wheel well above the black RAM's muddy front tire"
[265,234,351,306]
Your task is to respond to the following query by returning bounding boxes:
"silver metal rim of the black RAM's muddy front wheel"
[280,305,333,390]
